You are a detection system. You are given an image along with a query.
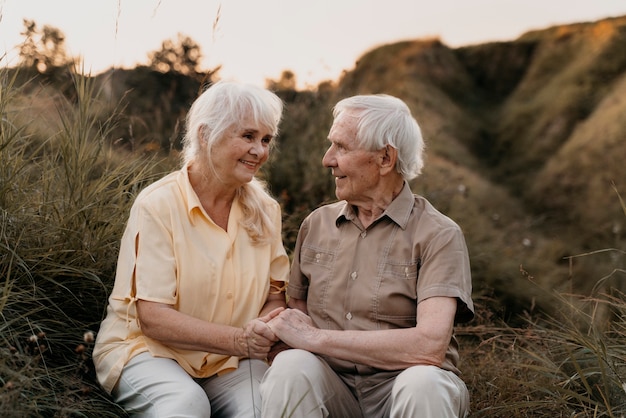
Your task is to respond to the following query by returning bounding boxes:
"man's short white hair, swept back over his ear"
[333,94,424,180]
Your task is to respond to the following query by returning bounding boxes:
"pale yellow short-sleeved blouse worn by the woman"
[93,167,289,393]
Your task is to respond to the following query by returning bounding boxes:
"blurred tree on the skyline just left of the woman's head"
[148,33,202,75]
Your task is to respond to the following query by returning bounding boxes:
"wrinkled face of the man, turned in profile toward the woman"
[322,113,380,206]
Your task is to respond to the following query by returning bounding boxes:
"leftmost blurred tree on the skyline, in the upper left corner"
[20,19,74,74]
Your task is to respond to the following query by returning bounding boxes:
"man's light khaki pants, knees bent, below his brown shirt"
[261,350,469,418]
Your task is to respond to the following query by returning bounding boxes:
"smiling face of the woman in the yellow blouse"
[211,120,273,187]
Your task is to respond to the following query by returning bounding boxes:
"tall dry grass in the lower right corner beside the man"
[459,197,626,418]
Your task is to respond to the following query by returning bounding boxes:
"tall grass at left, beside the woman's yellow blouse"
[0,64,169,416]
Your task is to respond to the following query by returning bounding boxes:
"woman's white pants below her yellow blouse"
[112,353,267,418]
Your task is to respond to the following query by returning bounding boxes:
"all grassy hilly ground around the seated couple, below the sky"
[0,17,626,417]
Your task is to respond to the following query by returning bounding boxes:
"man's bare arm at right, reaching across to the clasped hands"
[269,297,457,370]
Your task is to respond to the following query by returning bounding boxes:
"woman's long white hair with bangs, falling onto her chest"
[182,81,283,243]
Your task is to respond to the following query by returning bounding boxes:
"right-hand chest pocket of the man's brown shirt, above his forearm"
[376,260,419,328]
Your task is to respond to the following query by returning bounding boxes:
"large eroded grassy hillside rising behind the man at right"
[326,13,626,314]
